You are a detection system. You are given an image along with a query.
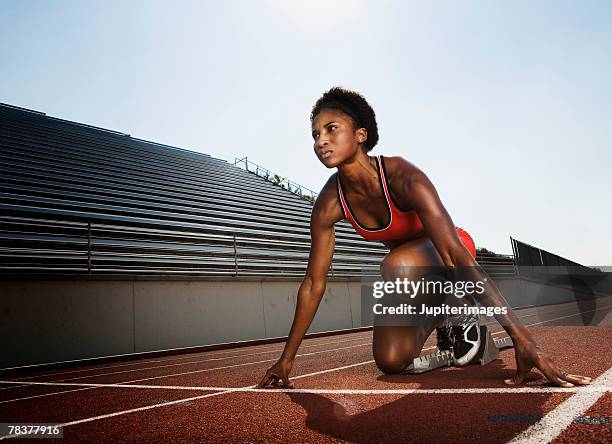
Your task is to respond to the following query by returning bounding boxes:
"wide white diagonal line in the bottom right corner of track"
[510,368,612,444]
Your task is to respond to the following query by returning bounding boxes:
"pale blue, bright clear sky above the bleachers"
[0,0,612,265]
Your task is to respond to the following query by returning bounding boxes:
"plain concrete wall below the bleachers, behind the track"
[0,277,608,368]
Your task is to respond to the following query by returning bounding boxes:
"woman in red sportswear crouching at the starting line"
[257,88,591,387]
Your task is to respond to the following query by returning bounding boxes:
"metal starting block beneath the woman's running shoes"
[404,325,513,375]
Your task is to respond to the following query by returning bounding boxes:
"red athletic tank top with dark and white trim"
[337,156,424,241]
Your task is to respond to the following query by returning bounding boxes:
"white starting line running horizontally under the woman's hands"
[0,374,612,396]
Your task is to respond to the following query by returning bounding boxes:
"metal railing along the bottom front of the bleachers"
[0,220,385,278]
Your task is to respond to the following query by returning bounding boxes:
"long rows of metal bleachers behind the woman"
[0,104,511,278]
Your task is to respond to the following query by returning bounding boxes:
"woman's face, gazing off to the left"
[312,110,365,168]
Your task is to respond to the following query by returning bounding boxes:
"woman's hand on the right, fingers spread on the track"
[504,340,591,387]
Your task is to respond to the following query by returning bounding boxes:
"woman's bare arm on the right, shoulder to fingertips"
[393,158,590,386]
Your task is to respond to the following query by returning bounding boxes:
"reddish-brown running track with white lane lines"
[0,298,612,443]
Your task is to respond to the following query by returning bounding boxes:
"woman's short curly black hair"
[310,86,378,151]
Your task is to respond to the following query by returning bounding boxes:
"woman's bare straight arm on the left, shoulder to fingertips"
[257,175,343,388]
